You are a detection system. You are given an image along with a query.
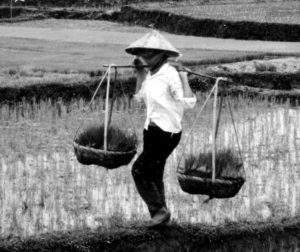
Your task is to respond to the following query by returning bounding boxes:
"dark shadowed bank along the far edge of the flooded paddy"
[0,73,300,104]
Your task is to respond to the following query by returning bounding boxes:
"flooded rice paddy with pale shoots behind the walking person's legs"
[0,97,300,239]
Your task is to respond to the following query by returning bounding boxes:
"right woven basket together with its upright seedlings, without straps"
[178,150,245,199]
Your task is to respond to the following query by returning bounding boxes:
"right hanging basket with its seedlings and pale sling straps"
[177,78,245,199]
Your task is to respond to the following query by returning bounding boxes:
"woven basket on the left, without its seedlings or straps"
[73,142,136,169]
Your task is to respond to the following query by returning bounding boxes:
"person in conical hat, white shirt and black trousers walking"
[125,30,196,227]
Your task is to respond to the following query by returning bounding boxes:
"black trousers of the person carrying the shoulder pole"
[132,125,181,217]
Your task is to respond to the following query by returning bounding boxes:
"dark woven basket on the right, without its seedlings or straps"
[178,173,245,198]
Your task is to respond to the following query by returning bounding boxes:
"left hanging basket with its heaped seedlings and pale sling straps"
[73,66,137,169]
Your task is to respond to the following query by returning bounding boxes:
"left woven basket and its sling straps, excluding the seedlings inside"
[73,65,137,169]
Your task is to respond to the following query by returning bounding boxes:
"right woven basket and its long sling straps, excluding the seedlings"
[177,76,245,202]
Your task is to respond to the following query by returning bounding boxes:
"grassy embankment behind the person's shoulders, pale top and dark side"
[0,57,300,104]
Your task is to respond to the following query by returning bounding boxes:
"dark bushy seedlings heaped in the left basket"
[75,125,137,152]
